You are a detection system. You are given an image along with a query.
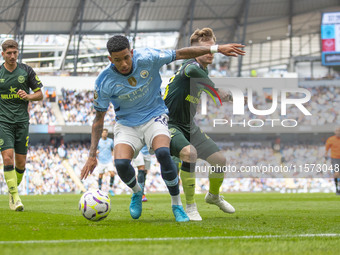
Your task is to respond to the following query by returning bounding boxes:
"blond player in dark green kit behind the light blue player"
[164,28,244,221]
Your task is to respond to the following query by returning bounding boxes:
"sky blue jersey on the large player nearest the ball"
[94,49,176,127]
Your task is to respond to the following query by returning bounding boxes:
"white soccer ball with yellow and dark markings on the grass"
[79,189,111,221]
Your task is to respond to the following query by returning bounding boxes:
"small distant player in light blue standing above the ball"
[96,128,115,196]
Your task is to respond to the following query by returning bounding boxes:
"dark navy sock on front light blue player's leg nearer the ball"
[115,159,139,189]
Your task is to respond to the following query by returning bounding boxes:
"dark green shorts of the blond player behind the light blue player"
[169,124,220,160]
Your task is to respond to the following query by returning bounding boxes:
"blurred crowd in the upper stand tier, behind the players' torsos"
[24,86,340,126]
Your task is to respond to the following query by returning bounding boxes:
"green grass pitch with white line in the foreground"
[0,193,340,255]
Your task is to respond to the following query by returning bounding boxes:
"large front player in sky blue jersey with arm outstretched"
[81,35,243,222]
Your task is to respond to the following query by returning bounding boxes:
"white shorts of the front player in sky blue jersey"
[113,114,170,158]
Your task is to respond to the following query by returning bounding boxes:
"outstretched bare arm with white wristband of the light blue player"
[176,43,246,60]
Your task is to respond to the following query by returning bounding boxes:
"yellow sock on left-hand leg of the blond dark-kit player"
[180,162,196,204]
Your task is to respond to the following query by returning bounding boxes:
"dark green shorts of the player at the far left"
[0,122,29,155]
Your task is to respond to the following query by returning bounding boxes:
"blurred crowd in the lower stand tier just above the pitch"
[0,142,334,194]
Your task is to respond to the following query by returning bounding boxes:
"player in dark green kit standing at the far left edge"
[0,39,43,211]
